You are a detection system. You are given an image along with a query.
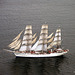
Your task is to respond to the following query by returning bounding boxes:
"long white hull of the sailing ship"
[14,51,67,57]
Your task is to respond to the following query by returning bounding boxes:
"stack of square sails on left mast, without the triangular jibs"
[19,25,32,51]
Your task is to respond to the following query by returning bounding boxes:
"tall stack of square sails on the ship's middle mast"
[36,25,48,52]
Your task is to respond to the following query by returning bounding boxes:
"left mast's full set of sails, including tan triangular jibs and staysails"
[8,25,37,52]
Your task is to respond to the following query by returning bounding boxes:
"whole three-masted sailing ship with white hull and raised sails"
[8,24,69,57]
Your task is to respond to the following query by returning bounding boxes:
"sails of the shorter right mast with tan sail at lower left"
[47,28,61,49]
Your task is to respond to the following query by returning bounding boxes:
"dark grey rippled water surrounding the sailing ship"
[0,0,75,75]
